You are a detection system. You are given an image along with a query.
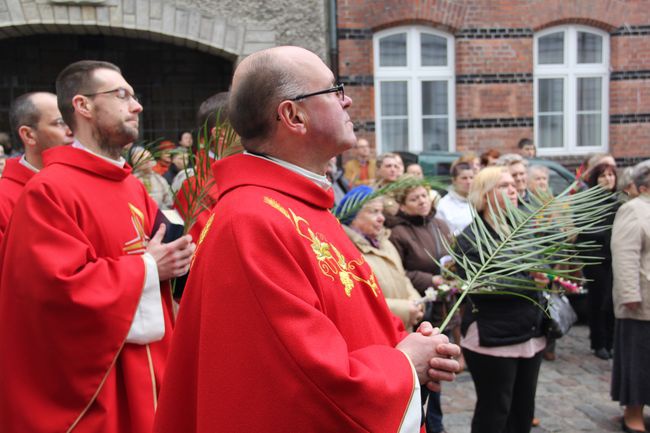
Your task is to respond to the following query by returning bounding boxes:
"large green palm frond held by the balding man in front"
[434,185,615,330]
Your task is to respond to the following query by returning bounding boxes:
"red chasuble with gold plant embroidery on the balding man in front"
[154,155,415,433]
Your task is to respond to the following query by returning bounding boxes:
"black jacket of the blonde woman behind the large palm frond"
[455,218,544,347]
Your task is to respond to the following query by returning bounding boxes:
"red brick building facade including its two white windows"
[337,0,650,160]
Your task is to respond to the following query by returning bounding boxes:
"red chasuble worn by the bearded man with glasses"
[0,146,172,433]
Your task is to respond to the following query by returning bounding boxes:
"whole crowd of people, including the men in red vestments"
[0,47,650,433]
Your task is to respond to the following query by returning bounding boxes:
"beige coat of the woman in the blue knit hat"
[343,225,420,329]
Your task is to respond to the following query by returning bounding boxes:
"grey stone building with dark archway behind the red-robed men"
[0,0,328,141]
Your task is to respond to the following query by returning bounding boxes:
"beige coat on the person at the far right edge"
[611,195,650,320]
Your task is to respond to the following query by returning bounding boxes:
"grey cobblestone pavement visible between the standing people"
[442,325,650,433]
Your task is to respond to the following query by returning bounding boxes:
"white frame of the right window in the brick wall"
[533,25,610,156]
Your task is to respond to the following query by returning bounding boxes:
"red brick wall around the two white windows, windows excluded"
[337,0,650,158]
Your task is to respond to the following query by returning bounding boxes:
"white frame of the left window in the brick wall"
[373,26,456,153]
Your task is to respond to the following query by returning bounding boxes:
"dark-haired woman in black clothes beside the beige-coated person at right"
[578,163,618,359]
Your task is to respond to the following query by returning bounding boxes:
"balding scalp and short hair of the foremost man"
[229,47,324,150]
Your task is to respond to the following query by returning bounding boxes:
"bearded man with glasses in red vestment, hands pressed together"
[0,61,194,433]
